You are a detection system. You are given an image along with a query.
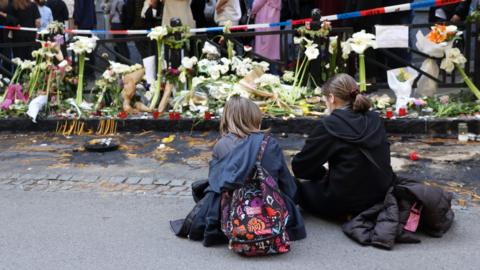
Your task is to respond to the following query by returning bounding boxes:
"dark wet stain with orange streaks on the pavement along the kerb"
[0,132,480,204]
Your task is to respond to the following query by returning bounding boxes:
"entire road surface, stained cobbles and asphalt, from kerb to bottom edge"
[0,133,480,270]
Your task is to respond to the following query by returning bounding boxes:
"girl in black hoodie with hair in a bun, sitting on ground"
[292,74,393,218]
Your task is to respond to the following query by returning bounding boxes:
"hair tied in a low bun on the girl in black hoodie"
[322,73,372,113]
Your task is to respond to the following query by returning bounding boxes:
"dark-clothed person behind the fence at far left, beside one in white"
[12,0,41,60]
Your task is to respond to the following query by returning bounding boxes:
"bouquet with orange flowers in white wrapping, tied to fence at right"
[416,24,462,96]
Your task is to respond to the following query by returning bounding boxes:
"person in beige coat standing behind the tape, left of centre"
[162,0,195,28]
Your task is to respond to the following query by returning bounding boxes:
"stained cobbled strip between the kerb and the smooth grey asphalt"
[0,132,480,205]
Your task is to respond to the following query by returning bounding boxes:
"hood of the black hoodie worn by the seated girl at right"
[323,109,385,148]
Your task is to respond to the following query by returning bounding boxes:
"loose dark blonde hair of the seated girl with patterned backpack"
[220,96,263,138]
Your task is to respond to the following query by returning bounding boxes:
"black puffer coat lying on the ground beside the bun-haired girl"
[343,176,454,249]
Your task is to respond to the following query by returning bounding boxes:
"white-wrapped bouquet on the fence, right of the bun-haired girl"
[387,67,418,113]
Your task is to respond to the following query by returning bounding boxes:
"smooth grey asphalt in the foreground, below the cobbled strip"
[0,190,480,270]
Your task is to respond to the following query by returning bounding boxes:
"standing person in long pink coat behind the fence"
[252,0,282,60]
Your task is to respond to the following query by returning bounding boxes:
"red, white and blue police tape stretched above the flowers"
[0,0,465,35]
